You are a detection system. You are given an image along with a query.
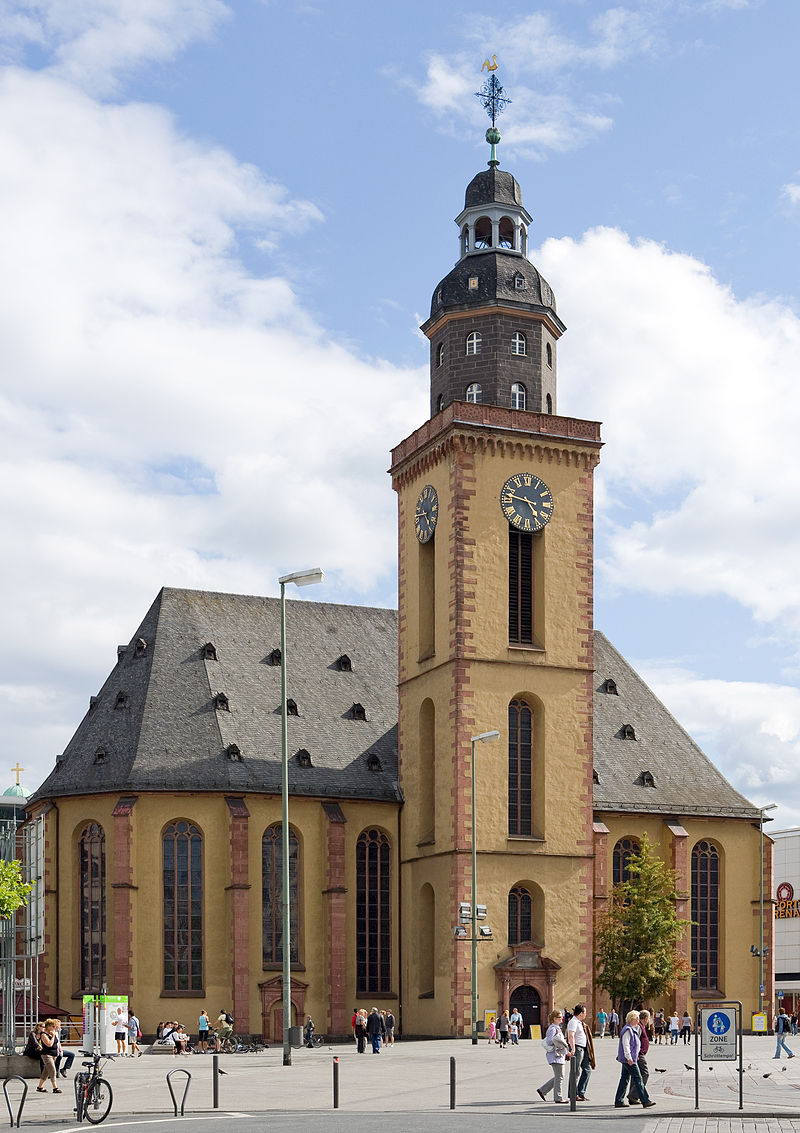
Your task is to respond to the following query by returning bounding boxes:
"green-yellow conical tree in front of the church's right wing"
[595,835,691,1005]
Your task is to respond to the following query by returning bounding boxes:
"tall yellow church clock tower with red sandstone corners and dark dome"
[391,97,601,1036]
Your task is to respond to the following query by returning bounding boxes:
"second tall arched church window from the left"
[161,820,203,991]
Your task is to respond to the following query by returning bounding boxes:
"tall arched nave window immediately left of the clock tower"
[356,830,392,995]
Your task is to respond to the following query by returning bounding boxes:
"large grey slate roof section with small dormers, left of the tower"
[34,588,400,801]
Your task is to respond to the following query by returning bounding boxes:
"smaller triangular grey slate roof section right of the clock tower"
[594,631,759,820]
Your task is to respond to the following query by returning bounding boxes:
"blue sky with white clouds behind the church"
[0,0,800,829]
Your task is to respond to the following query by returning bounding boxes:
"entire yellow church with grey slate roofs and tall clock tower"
[28,121,773,1041]
